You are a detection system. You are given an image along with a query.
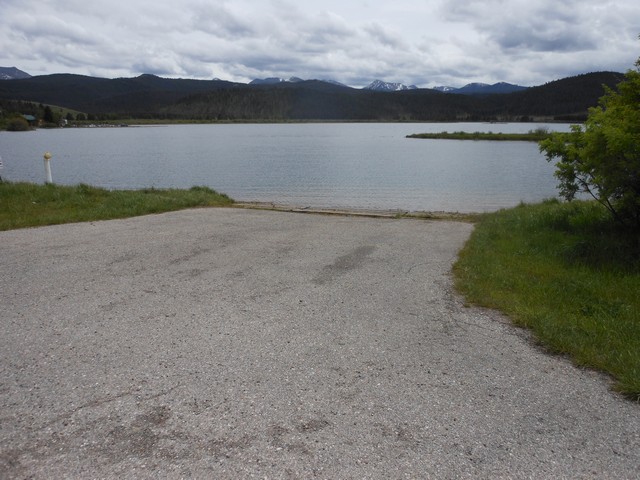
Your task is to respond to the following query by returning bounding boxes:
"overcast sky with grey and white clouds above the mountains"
[0,0,640,87]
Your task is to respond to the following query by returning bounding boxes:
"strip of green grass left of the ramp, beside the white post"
[0,182,233,230]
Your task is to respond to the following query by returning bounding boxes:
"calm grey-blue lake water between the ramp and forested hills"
[0,123,569,212]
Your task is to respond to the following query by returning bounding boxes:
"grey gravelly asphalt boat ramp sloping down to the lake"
[0,208,640,479]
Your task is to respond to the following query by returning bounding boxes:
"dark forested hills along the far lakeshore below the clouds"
[0,72,623,121]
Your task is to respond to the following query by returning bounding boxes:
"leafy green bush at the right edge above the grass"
[540,59,640,229]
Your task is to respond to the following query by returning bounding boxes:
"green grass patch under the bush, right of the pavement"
[454,197,640,400]
